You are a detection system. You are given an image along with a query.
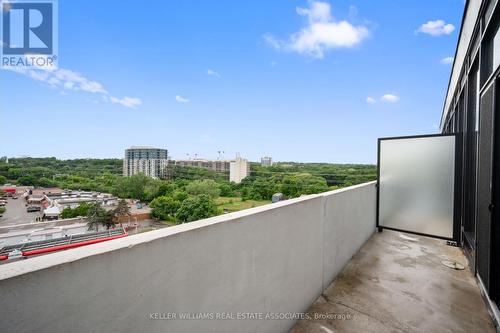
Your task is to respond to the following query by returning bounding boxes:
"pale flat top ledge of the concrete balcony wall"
[0,181,376,281]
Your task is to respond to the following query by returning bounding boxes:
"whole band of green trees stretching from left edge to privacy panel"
[0,158,376,222]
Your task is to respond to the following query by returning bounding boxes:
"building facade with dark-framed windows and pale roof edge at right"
[441,0,500,313]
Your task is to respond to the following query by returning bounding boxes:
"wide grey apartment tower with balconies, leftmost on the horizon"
[123,147,168,178]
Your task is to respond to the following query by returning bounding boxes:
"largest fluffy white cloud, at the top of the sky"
[263,1,370,59]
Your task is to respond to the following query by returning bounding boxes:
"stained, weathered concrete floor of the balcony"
[292,230,495,333]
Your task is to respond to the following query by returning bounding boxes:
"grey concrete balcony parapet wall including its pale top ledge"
[0,182,376,333]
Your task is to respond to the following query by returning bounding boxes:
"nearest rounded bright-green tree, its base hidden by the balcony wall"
[176,194,220,222]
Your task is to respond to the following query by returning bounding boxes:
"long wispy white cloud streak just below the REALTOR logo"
[4,67,142,108]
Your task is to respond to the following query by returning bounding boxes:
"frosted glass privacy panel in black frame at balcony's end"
[379,136,455,238]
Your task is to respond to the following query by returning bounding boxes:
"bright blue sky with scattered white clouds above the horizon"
[0,0,464,163]
